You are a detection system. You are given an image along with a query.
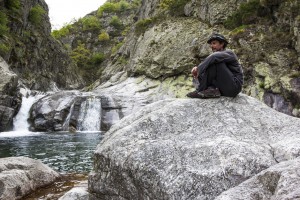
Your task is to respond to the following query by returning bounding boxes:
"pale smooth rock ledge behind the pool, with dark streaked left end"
[30,73,192,131]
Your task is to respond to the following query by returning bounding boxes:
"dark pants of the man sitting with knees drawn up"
[198,63,242,97]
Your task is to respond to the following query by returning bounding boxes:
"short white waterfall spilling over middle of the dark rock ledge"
[78,96,101,131]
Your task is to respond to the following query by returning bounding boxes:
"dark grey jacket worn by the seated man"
[198,50,244,85]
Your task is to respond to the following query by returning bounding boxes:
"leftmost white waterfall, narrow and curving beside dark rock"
[13,94,45,132]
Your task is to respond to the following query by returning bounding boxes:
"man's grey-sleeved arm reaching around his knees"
[198,50,237,75]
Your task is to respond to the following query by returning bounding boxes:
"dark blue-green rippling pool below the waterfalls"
[0,132,103,173]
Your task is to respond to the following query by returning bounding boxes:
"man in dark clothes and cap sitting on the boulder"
[187,33,244,98]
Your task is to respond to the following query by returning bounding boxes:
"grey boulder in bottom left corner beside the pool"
[0,157,60,200]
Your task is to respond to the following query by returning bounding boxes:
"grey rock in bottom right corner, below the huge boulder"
[216,158,300,200]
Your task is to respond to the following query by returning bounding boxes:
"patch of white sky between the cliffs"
[45,0,106,30]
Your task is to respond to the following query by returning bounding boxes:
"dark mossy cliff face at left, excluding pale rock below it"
[0,0,83,90]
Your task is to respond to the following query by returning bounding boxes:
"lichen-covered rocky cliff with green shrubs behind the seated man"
[54,0,300,116]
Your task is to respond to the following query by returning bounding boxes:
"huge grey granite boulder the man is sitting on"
[89,94,300,199]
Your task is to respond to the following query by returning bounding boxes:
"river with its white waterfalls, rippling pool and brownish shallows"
[0,94,104,200]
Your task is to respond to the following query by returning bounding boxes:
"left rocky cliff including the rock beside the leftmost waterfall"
[0,0,84,131]
